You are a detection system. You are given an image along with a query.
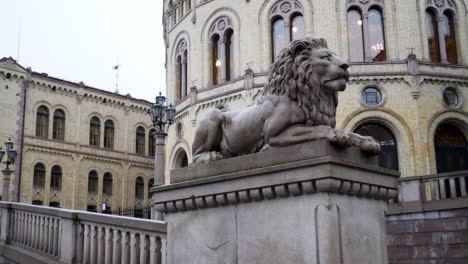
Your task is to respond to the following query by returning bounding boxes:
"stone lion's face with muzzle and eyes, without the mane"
[310,48,349,92]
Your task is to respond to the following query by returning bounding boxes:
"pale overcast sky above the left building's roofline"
[0,0,165,101]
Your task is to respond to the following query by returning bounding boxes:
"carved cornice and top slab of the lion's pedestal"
[151,140,399,213]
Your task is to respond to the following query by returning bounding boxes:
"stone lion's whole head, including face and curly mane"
[264,38,349,127]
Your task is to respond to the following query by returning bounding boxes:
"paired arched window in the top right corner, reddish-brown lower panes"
[426,0,458,64]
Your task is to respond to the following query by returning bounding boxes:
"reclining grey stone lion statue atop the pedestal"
[192,38,380,163]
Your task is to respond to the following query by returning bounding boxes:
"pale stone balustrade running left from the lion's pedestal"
[0,202,167,263]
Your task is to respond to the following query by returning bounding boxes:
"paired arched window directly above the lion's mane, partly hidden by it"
[270,0,305,61]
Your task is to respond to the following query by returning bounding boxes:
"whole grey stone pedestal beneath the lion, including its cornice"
[152,140,398,264]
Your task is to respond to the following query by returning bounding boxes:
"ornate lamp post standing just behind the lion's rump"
[148,93,176,190]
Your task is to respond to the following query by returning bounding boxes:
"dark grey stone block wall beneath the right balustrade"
[387,208,468,264]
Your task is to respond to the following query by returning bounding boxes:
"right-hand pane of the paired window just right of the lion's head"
[369,9,385,61]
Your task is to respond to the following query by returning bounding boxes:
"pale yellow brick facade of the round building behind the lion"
[164,0,468,182]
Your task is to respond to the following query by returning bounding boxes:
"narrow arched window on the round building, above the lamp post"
[175,39,188,100]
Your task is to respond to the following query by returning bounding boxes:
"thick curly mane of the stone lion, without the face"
[264,38,338,128]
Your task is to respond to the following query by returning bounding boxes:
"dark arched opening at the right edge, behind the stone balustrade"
[434,123,468,173]
